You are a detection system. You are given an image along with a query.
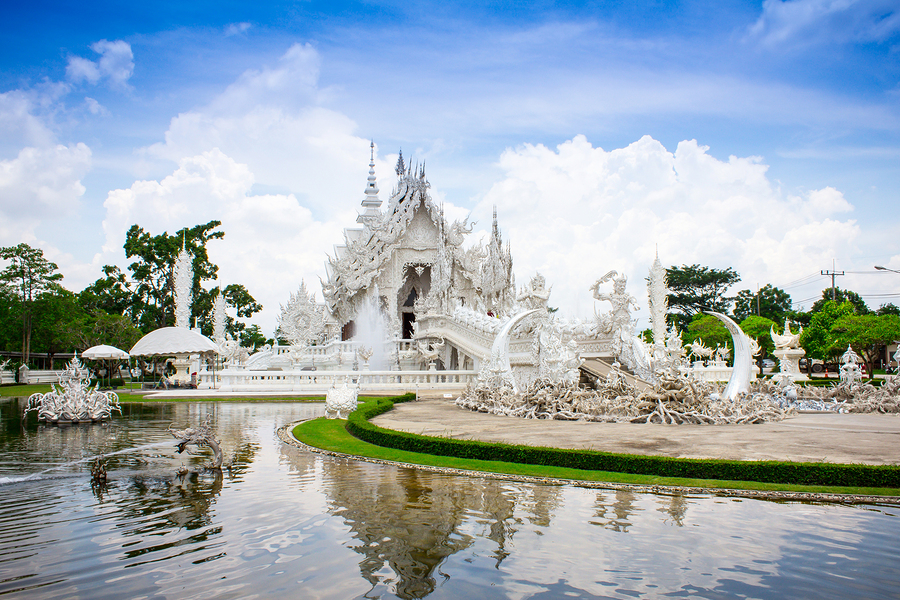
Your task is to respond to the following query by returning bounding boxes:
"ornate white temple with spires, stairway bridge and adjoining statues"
[201,144,683,391]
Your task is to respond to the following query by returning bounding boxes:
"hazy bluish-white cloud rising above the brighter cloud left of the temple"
[147,44,391,218]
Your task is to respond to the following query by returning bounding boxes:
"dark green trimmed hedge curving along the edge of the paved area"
[346,394,900,488]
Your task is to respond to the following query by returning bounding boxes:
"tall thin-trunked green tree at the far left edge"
[0,244,62,364]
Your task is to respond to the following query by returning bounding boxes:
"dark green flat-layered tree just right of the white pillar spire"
[666,265,741,330]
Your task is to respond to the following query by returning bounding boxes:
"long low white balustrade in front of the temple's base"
[199,370,478,393]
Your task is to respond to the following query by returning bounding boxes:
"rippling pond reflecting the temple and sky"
[0,399,900,599]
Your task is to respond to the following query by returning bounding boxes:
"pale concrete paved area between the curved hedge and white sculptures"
[372,399,900,465]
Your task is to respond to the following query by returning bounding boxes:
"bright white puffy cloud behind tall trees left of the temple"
[101,148,344,333]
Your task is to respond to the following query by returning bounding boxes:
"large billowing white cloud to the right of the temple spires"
[475,136,859,318]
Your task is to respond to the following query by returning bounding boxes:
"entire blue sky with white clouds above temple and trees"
[0,0,900,328]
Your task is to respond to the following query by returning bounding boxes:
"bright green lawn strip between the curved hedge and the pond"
[293,404,900,496]
